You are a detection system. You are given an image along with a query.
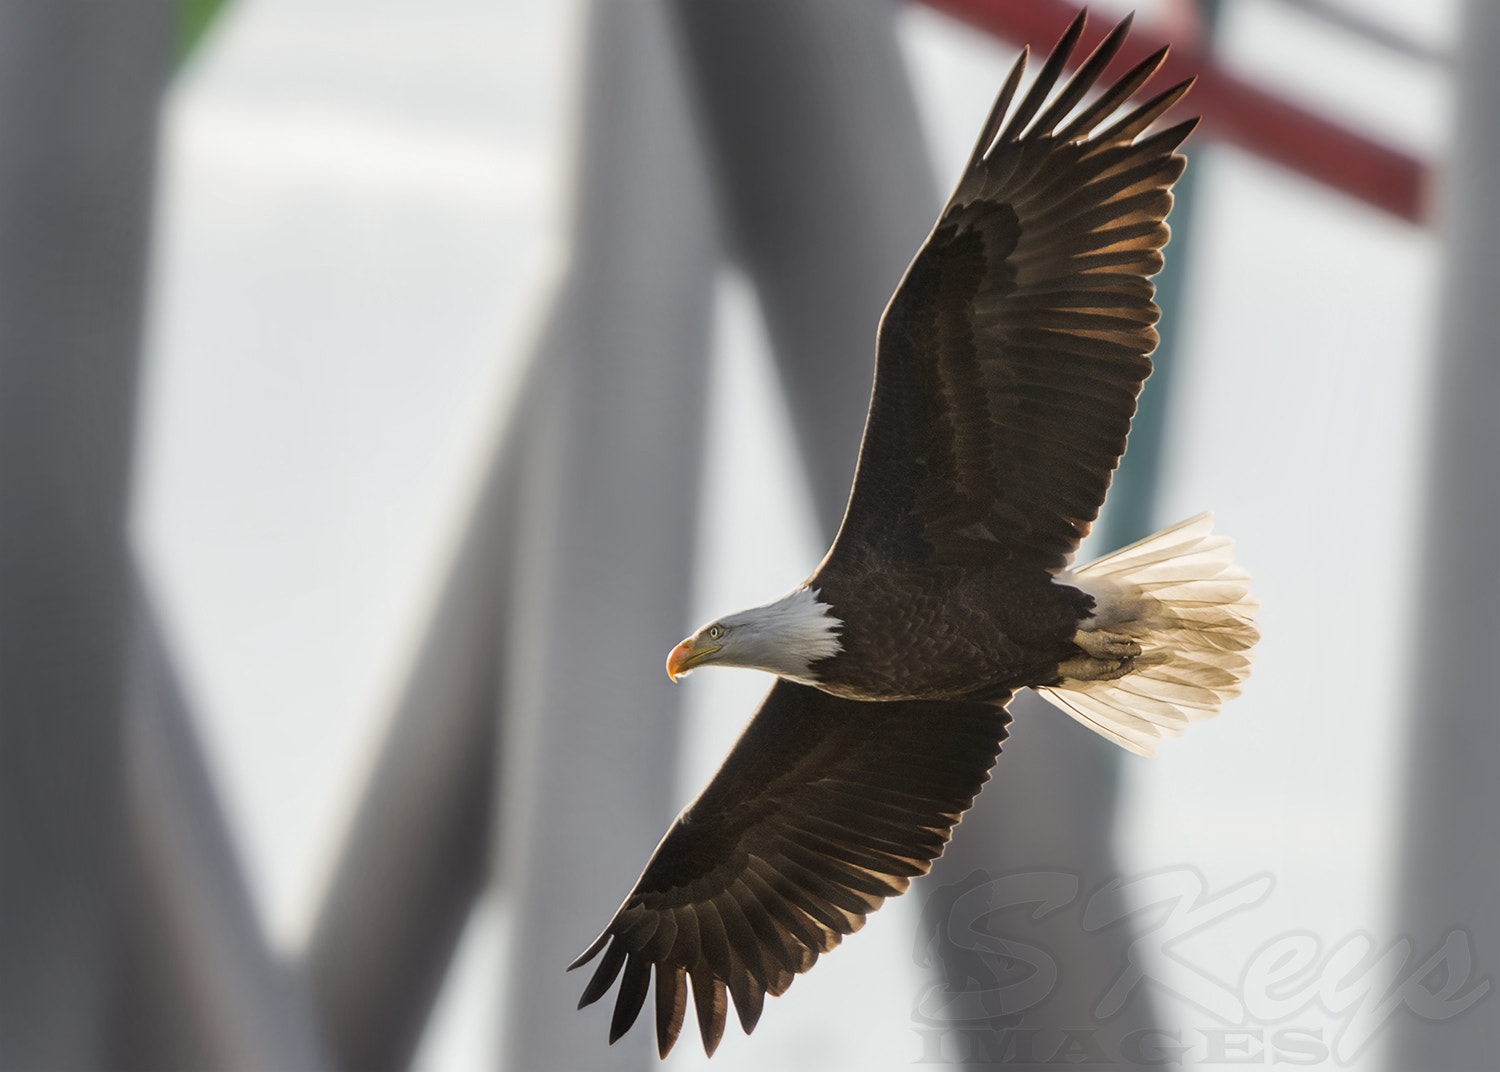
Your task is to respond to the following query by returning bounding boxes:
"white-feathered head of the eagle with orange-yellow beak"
[666,586,843,685]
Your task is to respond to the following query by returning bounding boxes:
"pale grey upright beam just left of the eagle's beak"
[501,0,717,1072]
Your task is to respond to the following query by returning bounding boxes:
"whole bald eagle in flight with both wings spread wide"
[570,15,1259,1057]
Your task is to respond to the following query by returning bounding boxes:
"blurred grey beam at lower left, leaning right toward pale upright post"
[308,362,536,1072]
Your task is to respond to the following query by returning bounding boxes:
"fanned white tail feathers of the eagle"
[1037,514,1260,756]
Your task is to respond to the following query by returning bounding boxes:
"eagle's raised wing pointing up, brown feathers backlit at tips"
[830,15,1197,570]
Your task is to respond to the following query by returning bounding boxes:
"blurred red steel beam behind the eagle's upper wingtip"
[924,0,1431,223]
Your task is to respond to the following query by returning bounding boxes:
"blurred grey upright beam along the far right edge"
[1388,0,1500,1069]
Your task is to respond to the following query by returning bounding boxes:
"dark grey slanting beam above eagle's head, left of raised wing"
[674,0,942,540]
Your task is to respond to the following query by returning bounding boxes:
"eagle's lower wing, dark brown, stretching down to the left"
[570,681,1010,1057]
